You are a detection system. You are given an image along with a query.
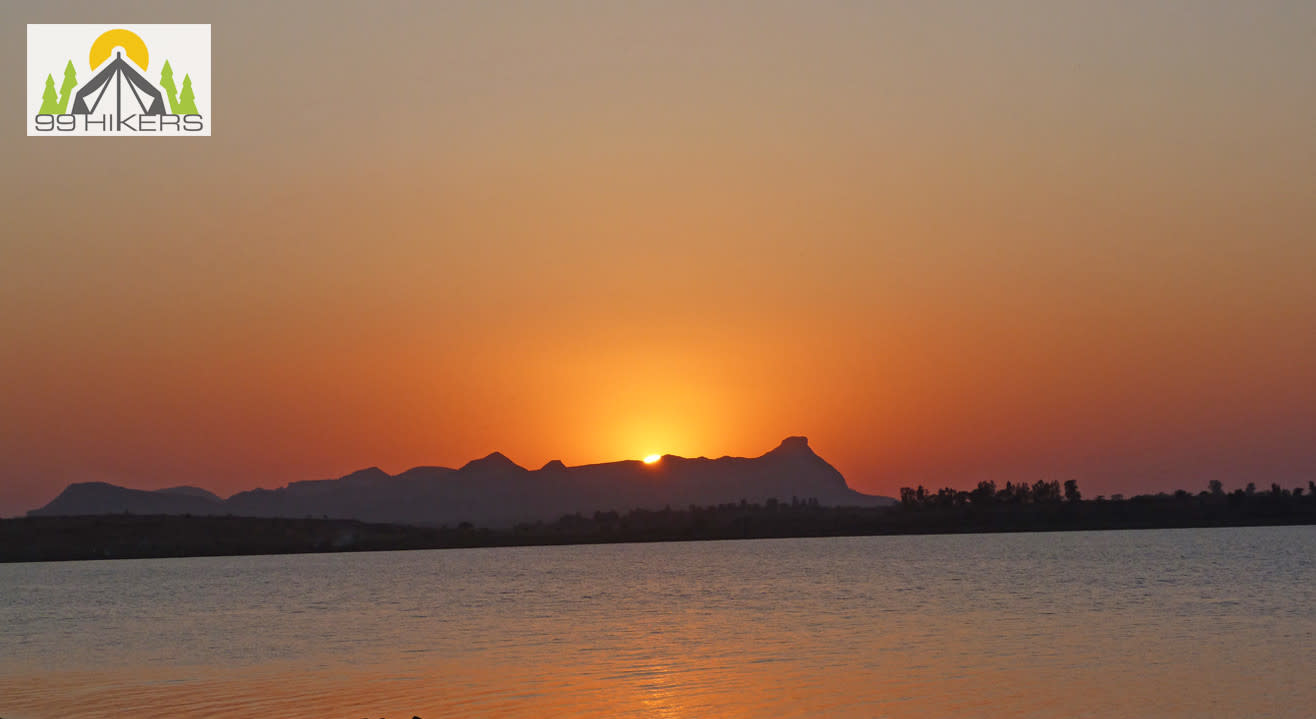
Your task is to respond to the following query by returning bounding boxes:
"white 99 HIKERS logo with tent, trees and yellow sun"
[28,25,211,137]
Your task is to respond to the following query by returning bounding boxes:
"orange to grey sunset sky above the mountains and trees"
[0,0,1316,516]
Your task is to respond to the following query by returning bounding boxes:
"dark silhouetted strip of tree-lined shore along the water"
[0,482,1316,561]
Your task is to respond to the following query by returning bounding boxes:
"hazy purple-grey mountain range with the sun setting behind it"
[28,437,894,527]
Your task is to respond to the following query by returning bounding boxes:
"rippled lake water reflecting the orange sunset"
[0,527,1316,719]
